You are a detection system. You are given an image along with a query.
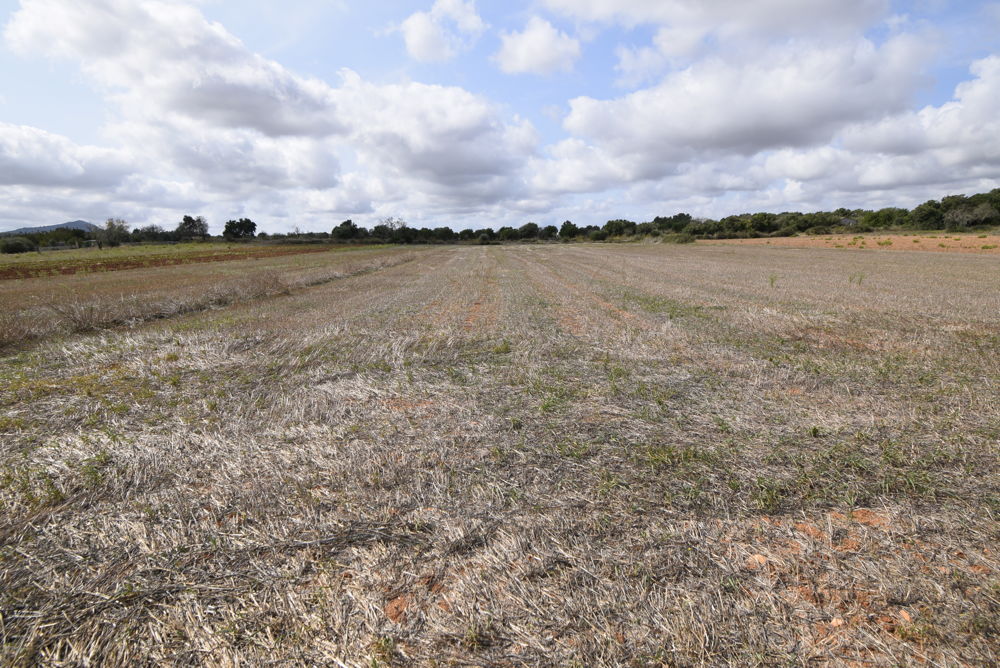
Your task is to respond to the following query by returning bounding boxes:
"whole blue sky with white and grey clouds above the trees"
[0,0,1000,233]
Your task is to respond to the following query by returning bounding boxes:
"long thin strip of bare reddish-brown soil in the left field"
[0,246,334,280]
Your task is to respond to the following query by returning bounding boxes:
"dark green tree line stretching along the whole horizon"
[0,188,1000,253]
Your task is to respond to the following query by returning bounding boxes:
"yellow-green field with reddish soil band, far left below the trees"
[0,243,360,281]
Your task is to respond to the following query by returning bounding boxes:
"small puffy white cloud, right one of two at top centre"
[494,16,580,74]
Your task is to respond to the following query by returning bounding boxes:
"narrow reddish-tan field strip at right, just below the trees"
[699,232,1000,255]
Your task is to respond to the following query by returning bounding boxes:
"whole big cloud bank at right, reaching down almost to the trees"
[532,30,1000,215]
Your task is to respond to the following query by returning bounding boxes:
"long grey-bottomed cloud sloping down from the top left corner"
[4,0,343,136]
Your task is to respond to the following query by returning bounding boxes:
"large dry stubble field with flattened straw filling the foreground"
[0,243,1000,666]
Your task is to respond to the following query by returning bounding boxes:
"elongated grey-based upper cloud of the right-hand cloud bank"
[565,36,926,174]
